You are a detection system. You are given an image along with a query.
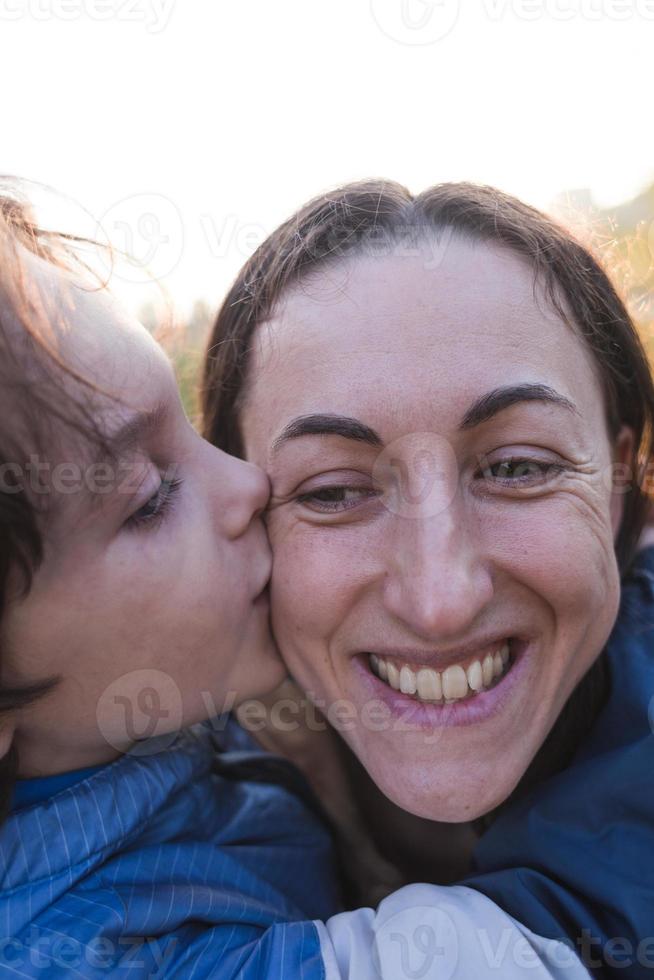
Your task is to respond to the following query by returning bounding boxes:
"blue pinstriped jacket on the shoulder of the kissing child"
[0,712,340,972]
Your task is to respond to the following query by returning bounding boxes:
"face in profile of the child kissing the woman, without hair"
[3,263,285,775]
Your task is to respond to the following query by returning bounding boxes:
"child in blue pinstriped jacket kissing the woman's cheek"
[0,199,339,977]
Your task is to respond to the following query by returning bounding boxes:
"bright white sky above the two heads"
[0,0,654,312]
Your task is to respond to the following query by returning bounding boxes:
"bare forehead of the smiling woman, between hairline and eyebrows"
[244,240,601,444]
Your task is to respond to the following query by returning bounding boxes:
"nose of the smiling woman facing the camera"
[384,504,493,638]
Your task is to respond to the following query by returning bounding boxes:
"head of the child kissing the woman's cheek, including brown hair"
[0,189,283,812]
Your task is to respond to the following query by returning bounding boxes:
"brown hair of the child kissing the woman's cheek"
[0,185,107,823]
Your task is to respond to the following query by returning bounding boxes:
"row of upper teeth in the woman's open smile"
[370,642,509,703]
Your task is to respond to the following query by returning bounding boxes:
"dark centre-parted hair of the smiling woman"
[202,180,654,808]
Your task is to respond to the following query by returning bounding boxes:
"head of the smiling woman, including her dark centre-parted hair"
[204,182,654,972]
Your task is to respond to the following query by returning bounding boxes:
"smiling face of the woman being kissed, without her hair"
[242,239,629,821]
